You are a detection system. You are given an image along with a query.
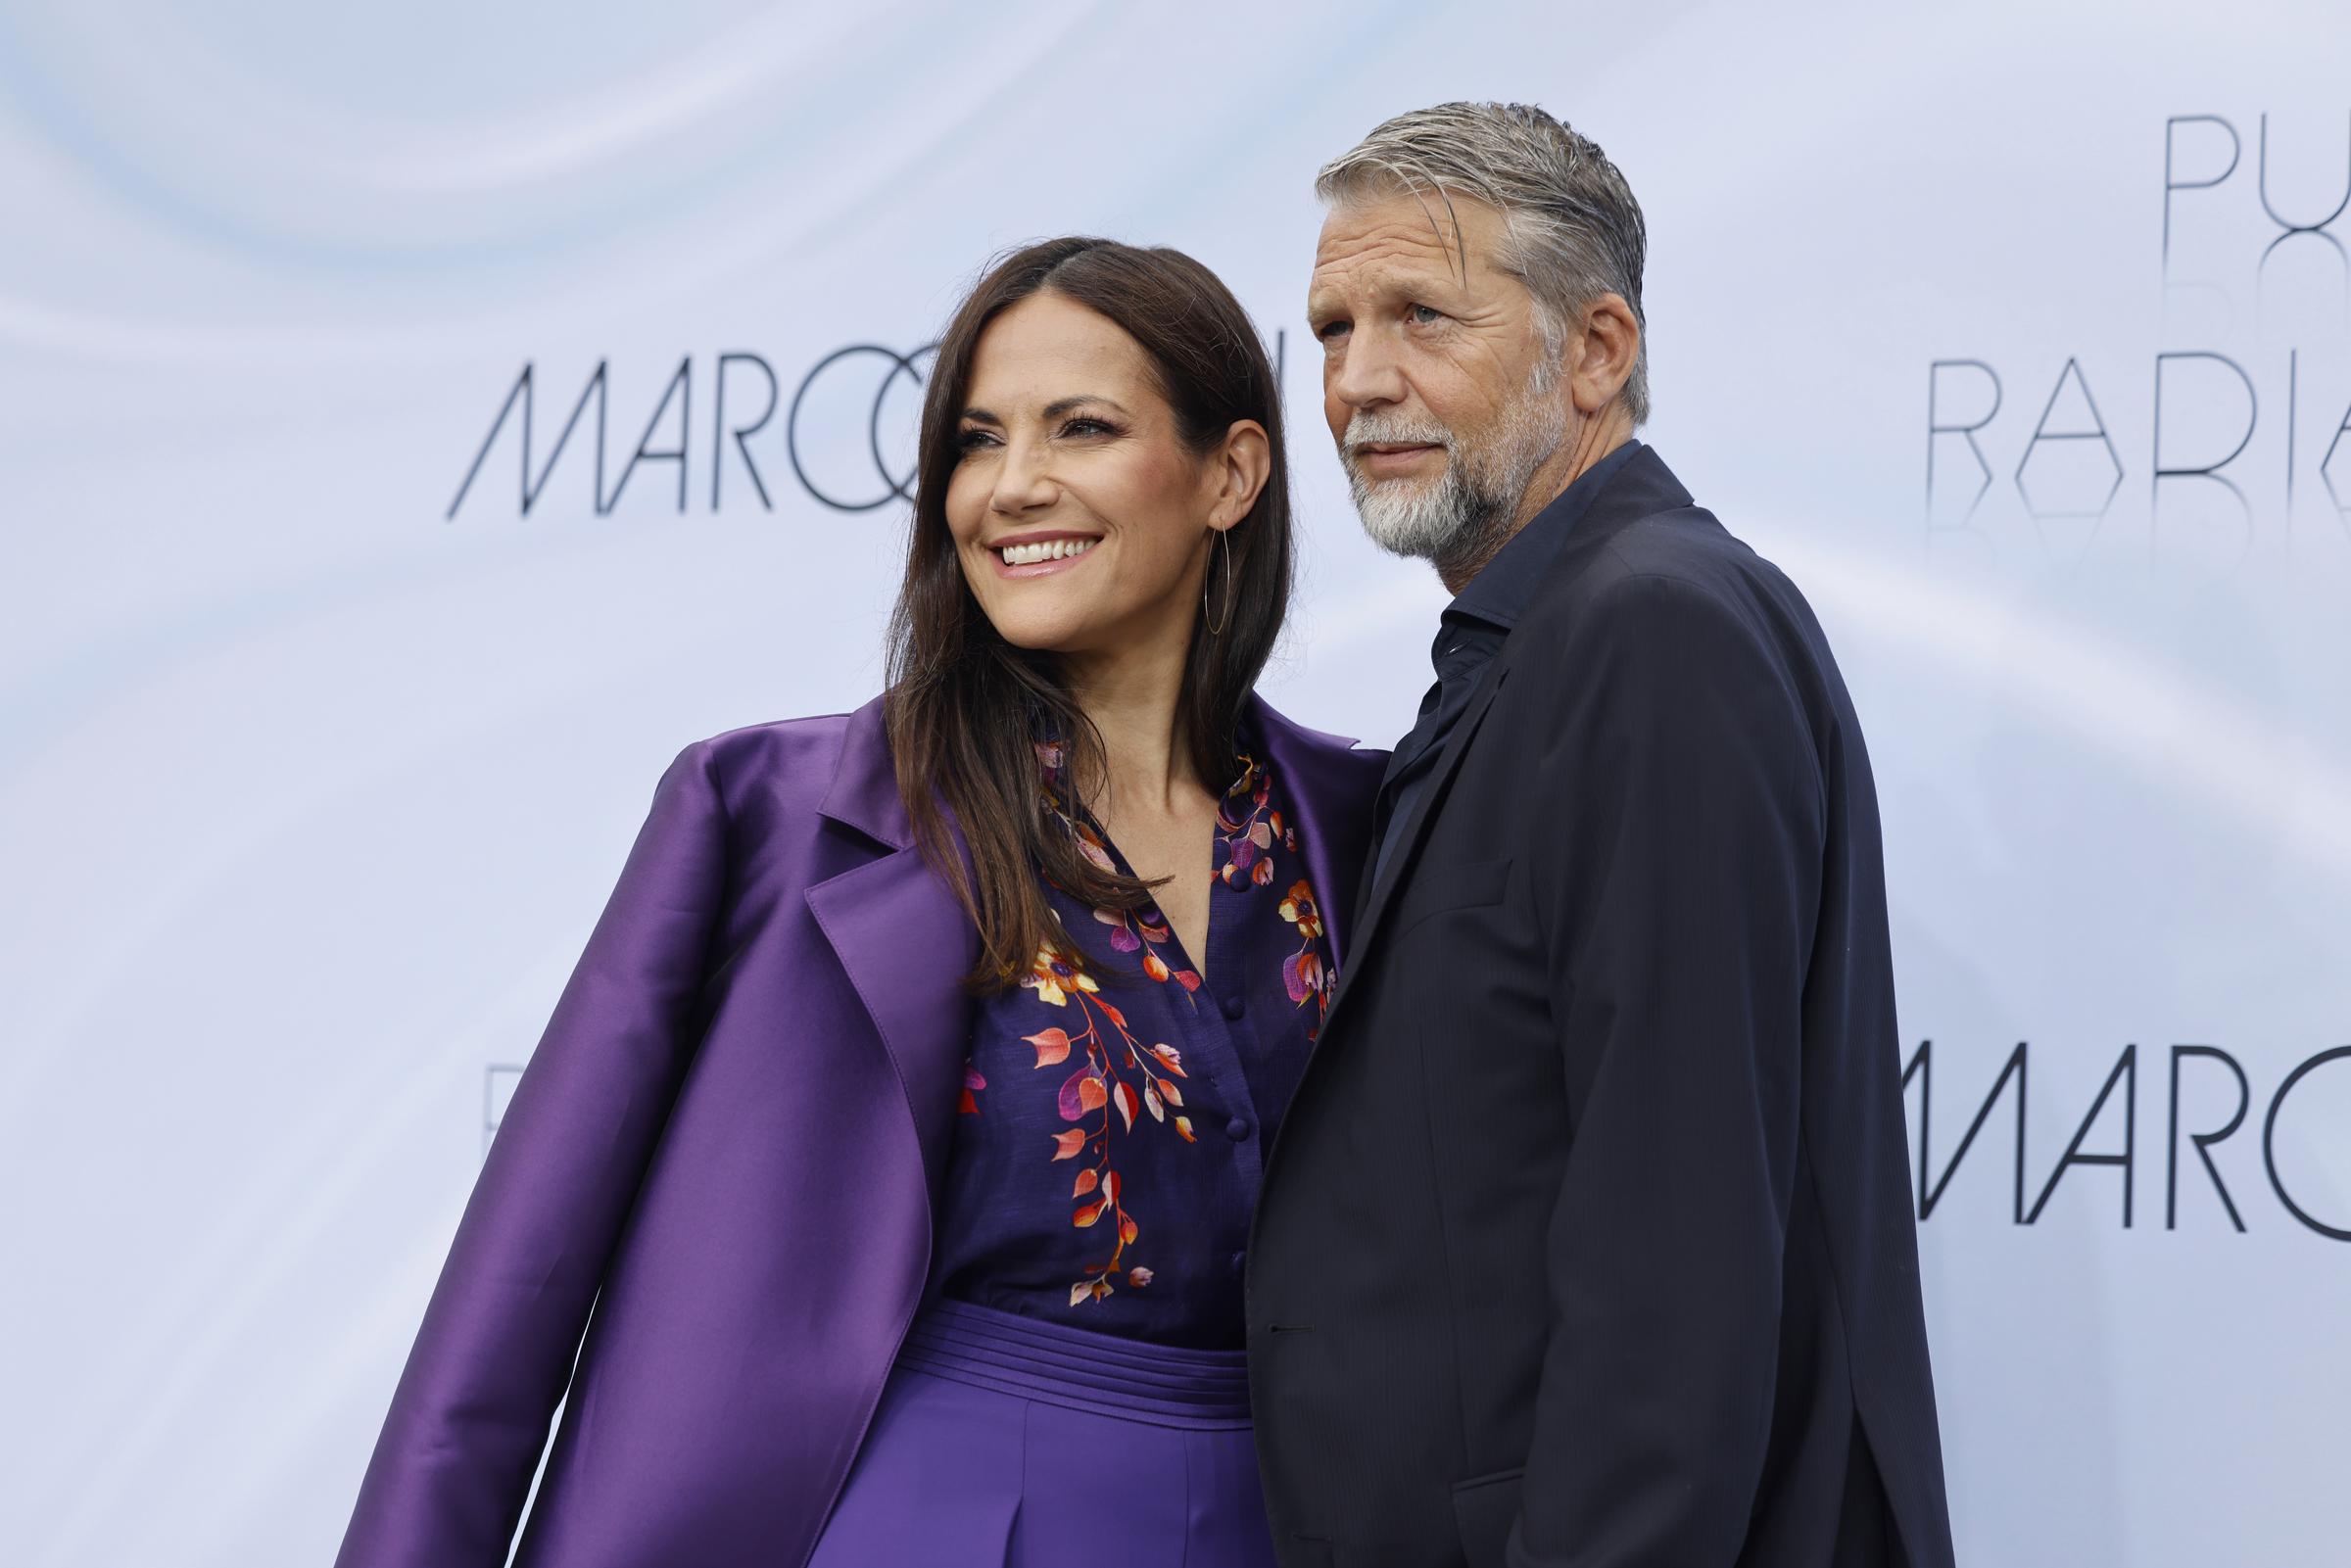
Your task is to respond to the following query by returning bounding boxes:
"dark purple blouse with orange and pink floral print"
[931,738,1338,1350]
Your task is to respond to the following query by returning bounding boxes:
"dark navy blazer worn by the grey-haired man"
[1248,449,1951,1568]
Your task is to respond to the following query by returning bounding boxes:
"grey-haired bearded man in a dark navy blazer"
[1248,104,1951,1568]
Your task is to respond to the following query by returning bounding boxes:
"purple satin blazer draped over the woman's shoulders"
[336,698,1385,1568]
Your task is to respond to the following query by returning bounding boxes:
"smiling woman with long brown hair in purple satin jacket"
[339,240,1380,1568]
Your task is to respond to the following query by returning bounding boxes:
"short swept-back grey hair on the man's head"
[1315,104,1648,425]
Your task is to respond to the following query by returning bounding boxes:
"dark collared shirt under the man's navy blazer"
[1364,440,1641,898]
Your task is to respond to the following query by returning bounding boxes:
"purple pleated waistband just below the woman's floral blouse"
[898,1300,1248,1429]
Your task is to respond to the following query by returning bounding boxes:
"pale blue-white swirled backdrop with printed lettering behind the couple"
[0,0,2351,1568]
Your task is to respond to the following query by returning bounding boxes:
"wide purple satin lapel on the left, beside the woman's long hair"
[806,698,981,1194]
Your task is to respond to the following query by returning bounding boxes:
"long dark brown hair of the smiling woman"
[884,237,1291,994]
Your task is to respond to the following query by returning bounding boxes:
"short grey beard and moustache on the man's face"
[1345,388,1568,566]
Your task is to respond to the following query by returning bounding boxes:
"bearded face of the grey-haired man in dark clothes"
[1307,190,1573,569]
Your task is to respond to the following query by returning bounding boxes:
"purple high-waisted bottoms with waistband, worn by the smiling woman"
[809,1303,1274,1568]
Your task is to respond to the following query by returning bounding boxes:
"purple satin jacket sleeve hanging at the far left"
[336,742,727,1568]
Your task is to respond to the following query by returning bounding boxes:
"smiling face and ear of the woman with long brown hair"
[947,294,1265,656]
